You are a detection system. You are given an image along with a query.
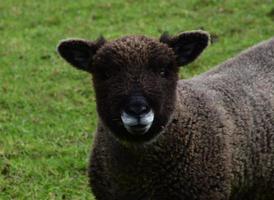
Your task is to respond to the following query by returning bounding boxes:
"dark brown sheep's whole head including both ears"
[58,31,209,142]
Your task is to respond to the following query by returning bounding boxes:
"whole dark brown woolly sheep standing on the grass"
[58,30,274,200]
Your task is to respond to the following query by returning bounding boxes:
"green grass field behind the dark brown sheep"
[0,0,274,200]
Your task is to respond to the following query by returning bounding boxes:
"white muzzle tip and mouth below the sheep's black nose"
[121,110,154,136]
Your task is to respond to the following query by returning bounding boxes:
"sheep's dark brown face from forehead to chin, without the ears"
[93,36,178,141]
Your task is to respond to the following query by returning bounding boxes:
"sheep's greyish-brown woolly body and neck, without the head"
[89,39,274,200]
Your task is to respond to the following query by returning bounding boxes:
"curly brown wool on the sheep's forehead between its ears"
[96,35,174,70]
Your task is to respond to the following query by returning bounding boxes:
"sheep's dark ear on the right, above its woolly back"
[160,30,210,66]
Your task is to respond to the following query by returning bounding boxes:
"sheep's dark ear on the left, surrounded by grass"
[57,37,105,72]
